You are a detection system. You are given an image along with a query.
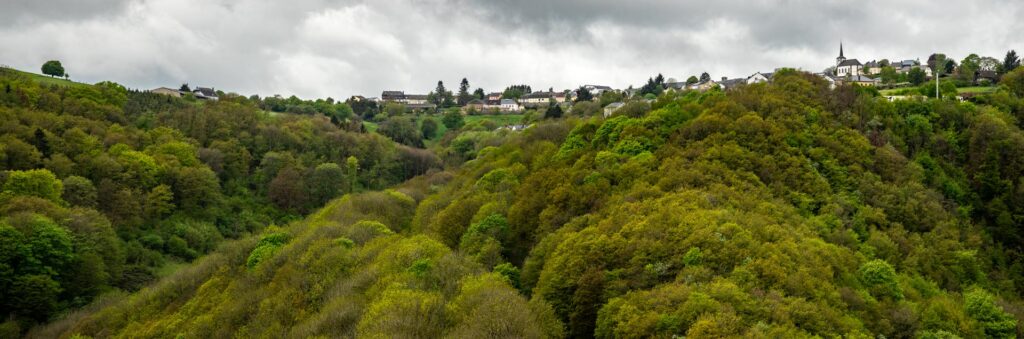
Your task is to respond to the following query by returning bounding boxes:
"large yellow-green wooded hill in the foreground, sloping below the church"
[12,69,1024,338]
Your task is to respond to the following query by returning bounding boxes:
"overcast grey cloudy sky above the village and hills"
[0,0,1024,98]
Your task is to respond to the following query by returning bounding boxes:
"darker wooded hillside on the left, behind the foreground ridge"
[0,69,437,333]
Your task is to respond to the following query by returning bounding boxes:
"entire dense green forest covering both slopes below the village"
[6,65,1024,338]
